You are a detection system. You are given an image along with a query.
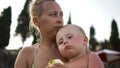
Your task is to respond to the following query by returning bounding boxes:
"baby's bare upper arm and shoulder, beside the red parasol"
[88,52,104,68]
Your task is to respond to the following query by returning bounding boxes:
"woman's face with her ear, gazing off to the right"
[38,1,63,36]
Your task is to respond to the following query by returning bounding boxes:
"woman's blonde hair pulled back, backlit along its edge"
[29,0,55,33]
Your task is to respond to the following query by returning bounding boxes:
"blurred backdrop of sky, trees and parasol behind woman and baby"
[0,0,120,68]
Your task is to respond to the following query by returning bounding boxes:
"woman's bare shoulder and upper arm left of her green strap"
[14,45,37,68]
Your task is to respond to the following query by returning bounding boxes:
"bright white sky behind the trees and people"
[0,0,120,49]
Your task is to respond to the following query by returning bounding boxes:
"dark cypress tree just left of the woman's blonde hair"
[15,0,31,43]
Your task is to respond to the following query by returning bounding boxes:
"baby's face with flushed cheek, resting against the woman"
[56,26,86,59]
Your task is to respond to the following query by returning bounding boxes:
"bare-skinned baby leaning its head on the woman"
[55,25,104,68]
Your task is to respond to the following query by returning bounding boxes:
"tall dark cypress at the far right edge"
[110,20,120,51]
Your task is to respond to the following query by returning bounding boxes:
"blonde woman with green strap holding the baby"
[14,0,64,68]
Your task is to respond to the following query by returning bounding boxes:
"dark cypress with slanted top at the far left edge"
[0,7,11,48]
